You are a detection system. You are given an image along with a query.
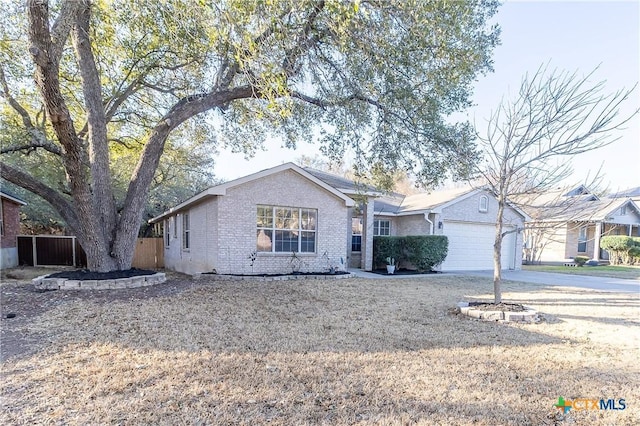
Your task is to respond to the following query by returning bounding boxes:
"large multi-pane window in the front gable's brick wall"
[256,206,318,253]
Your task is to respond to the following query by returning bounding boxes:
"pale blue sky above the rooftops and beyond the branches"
[215,1,640,191]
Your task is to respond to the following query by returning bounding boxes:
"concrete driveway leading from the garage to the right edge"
[457,271,640,294]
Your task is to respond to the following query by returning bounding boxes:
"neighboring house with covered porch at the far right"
[520,185,640,262]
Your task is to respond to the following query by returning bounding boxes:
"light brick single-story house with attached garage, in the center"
[151,163,526,274]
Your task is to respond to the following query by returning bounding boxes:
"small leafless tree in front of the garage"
[473,67,638,303]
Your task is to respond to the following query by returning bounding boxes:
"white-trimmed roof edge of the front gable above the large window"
[149,163,355,223]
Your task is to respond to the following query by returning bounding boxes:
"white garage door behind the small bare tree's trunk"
[442,222,516,271]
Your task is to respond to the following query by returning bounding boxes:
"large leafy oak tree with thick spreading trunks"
[0,0,498,271]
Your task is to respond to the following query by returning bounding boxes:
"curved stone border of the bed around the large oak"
[31,272,167,290]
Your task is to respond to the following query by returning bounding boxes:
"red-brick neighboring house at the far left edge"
[0,192,27,269]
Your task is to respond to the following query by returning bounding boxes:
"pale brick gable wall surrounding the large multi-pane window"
[165,170,348,274]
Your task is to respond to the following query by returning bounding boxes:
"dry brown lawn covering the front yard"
[0,275,640,425]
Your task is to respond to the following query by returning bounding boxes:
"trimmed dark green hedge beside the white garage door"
[373,235,449,271]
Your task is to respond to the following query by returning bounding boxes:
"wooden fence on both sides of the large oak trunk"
[18,235,164,269]
